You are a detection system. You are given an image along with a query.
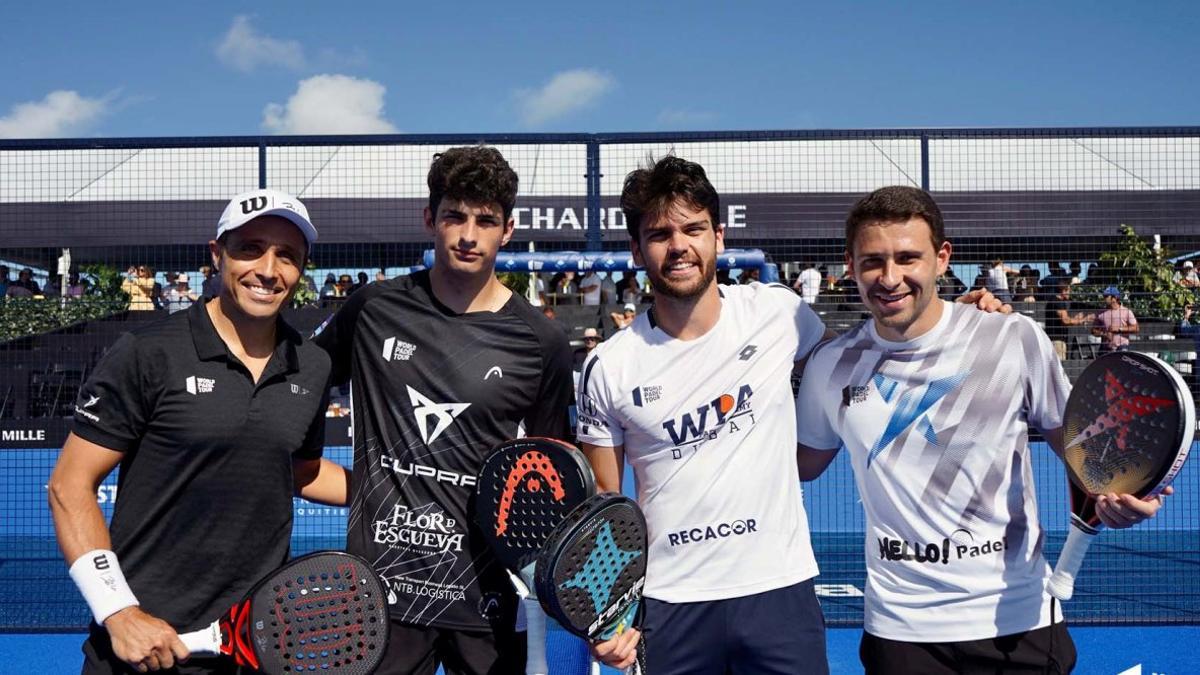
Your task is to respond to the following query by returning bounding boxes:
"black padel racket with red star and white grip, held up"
[1049,352,1196,601]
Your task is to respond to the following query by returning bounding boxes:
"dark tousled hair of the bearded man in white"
[620,155,721,240]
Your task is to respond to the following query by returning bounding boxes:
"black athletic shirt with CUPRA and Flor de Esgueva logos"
[314,271,574,631]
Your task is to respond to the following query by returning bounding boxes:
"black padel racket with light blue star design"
[535,494,647,673]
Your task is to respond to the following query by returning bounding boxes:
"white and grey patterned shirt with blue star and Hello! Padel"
[796,300,1070,643]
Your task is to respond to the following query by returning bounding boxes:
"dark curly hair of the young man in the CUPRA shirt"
[428,145,517,221]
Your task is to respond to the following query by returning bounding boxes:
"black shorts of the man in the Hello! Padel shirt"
[858,622,1075,675]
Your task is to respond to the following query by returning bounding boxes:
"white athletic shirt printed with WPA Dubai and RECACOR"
[578,283,824,603]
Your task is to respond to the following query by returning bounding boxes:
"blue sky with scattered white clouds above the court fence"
[0,1,1200,138]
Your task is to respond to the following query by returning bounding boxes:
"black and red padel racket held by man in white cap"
[179,551,388,675]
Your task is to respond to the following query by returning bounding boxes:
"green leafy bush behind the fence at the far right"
[1086,225,1195,321]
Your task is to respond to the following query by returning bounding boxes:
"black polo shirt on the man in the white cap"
[73,303,329,631]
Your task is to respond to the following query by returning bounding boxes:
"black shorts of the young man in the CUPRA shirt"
[376,620,526,675]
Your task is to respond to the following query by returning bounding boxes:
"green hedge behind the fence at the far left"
[0,265,130,342]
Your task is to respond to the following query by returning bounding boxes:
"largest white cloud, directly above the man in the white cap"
[263,74,396,133]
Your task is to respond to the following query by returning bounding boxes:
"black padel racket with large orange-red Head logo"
[474,438,596,675]
